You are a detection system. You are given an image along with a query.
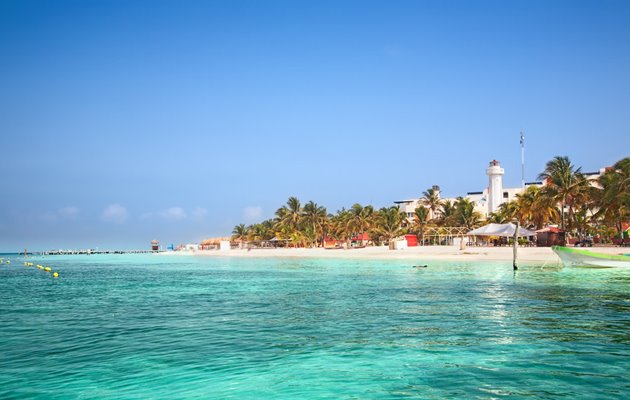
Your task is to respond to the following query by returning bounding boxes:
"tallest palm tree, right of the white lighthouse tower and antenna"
[538,156,590,230]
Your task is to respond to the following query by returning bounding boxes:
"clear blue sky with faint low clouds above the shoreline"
[0,0,630,251]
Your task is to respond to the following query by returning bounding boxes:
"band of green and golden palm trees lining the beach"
[232,157,630,247]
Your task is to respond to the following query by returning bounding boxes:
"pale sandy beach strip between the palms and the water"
[161,246,629,263]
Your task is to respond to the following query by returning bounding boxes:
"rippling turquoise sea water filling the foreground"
[0,255,630,399]
